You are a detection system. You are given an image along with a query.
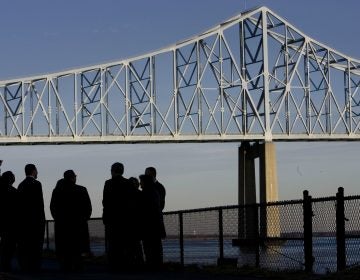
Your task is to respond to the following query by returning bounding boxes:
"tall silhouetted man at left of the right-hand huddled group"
[103,162,139,270]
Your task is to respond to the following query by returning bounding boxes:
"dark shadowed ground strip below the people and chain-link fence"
[0,259,360,280]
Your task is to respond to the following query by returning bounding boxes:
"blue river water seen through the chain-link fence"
[85,237,360,273]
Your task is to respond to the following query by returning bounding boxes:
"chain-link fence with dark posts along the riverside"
[45,188,360,273]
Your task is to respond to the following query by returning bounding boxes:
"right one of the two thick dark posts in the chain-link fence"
[336,187,346,271]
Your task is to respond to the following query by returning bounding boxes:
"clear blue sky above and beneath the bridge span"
[0,0,360,218]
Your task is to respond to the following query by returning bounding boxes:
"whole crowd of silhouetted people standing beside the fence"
[0,162,166,273]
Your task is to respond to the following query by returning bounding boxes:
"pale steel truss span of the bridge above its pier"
[0,7,360,144]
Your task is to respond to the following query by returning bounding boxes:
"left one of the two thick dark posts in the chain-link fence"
[303,190,314,272]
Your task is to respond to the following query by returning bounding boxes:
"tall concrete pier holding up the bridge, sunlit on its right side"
[238,142,280,239]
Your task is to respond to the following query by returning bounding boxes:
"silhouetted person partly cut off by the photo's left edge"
[0,171,19,272]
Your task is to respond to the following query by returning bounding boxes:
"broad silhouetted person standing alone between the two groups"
[50,170,92,271]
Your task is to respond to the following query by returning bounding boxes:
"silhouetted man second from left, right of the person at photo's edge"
[18,164,45,272]
